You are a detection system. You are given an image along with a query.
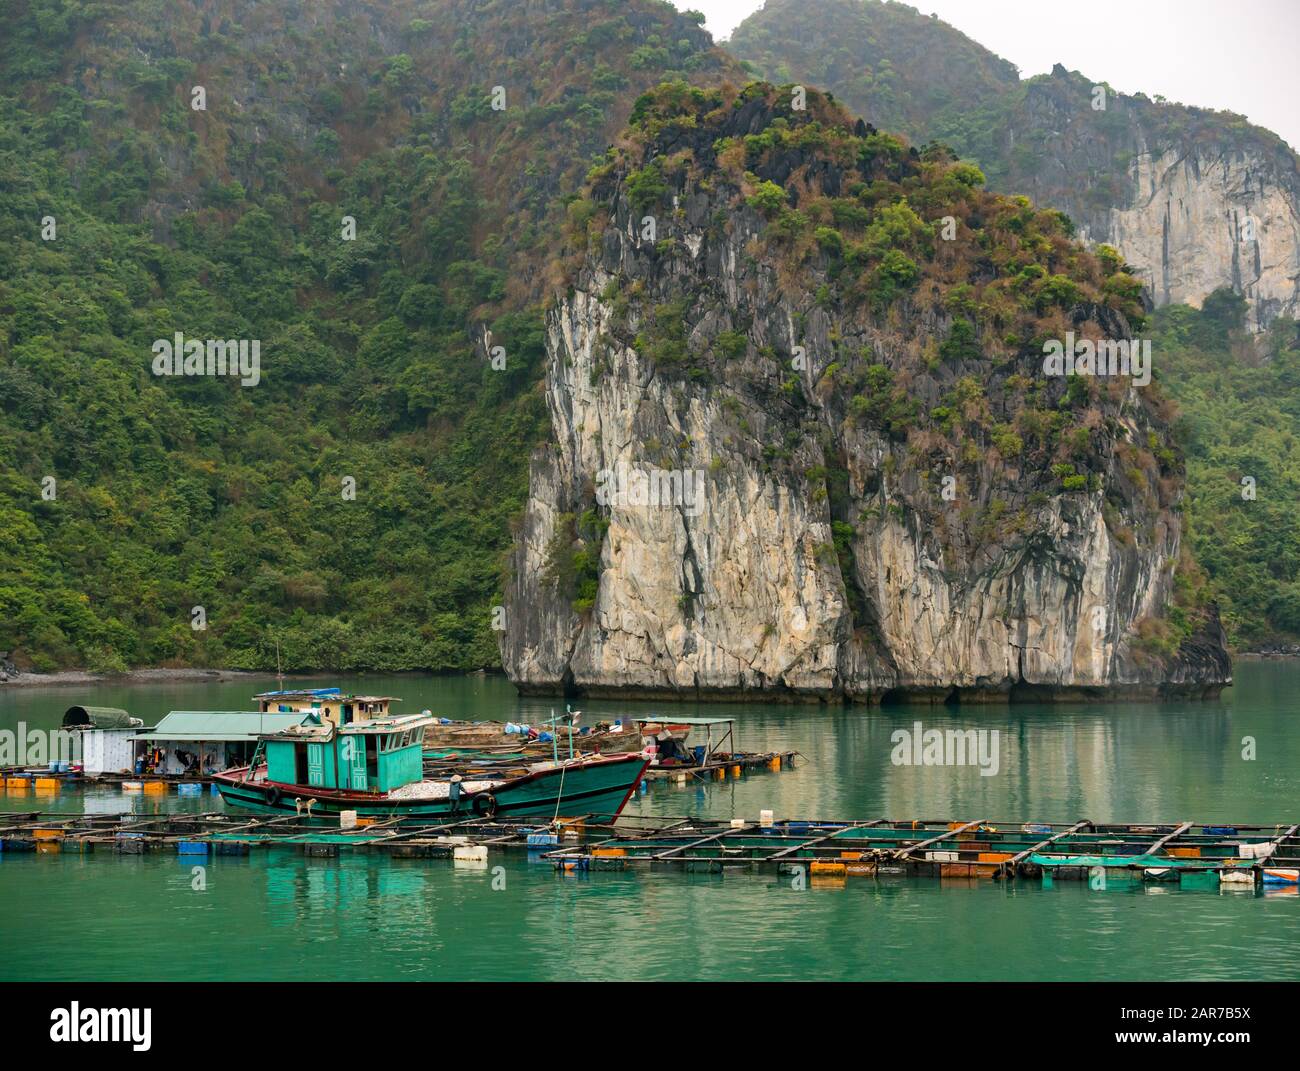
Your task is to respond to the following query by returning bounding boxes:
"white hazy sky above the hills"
[673,0,1300,148]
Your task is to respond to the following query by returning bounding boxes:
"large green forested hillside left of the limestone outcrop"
[0,0,731,669]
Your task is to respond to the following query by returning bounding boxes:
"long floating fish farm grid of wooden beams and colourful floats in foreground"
[0,811,1300,892]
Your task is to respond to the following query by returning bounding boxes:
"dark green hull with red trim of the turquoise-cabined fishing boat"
[213,755,647,824]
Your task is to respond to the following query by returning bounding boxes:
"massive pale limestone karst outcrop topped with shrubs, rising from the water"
[502,88,1230,701]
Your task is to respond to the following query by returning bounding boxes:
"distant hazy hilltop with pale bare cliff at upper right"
[991,66,1300,331]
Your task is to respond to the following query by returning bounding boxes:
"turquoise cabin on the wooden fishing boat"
[263,715,433,792]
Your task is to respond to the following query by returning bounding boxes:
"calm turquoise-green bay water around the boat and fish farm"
[0,662,1300,980]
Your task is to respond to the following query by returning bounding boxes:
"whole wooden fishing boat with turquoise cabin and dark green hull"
[213,715,646,823]
